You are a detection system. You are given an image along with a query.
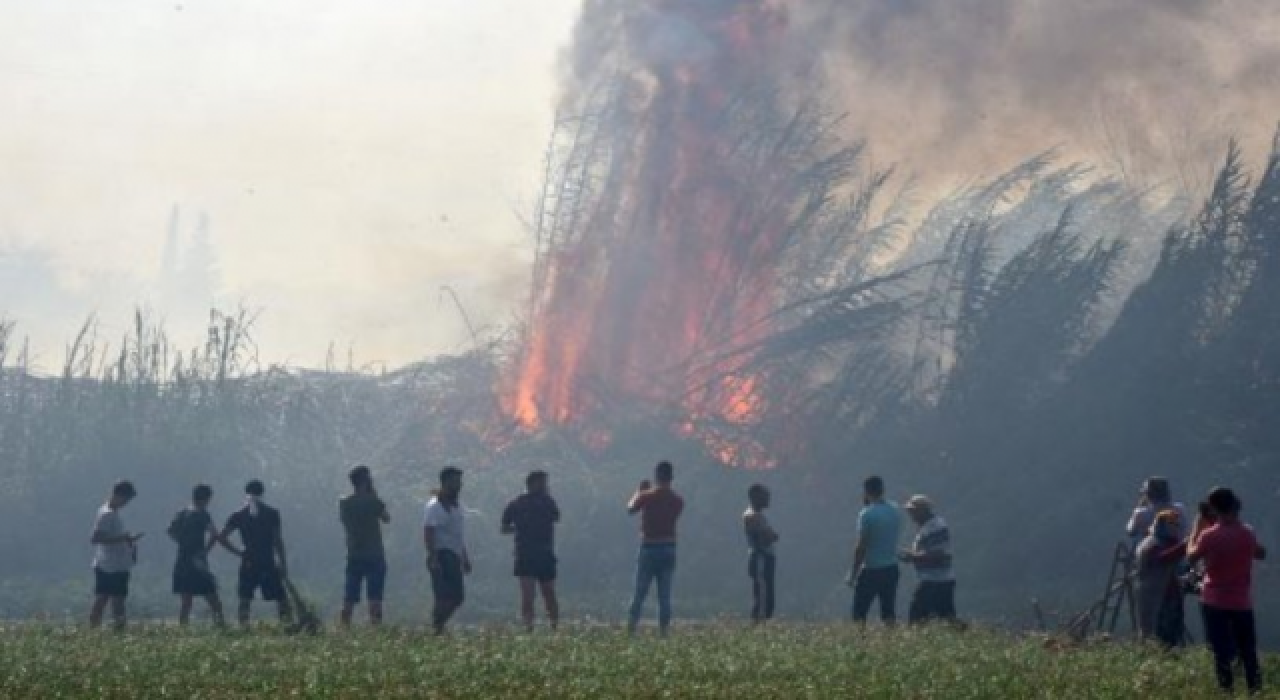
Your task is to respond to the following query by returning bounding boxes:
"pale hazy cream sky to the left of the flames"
[0,0,579,365]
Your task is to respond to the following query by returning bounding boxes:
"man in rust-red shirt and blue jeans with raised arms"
[627,462,685,636]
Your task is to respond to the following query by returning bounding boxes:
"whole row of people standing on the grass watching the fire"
[90,462,1266,690]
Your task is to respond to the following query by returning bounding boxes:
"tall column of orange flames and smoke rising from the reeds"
[503,0,791,463]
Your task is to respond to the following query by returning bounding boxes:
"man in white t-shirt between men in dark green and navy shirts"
[422,467,471,635]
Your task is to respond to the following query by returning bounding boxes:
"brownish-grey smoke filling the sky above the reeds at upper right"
[786,0,1280,187]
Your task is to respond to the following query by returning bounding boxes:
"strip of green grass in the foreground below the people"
[0,624,1280,699]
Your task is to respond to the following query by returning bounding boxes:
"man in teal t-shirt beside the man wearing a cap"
[846,476,902,624]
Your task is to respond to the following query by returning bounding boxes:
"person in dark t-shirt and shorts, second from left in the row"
[169,484,242,627]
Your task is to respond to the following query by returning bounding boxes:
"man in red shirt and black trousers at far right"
[1187,488,1266,692]
